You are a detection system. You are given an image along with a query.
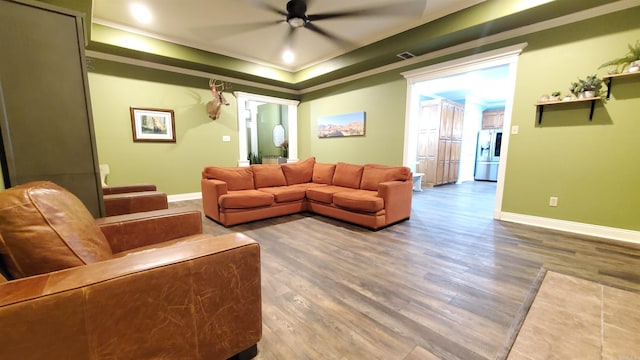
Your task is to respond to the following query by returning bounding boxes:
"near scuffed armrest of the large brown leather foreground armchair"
[0,233,262,359]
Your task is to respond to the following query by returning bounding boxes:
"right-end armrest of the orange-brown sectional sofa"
[378,180,413,224]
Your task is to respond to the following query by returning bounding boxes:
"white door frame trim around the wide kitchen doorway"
[402,43,527,219]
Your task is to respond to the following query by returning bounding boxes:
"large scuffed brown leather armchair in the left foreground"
[0,182,262,359]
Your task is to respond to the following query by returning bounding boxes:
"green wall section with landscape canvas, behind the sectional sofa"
[298,80,406,165]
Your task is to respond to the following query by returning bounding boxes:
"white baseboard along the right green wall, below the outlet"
[496,212,640,244]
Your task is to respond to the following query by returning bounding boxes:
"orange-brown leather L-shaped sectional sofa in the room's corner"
[201,158,413,229]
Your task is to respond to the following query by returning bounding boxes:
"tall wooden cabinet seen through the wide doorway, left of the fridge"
[416,99,464,187]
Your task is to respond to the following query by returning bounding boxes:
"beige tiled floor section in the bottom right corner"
[496,269,640,360]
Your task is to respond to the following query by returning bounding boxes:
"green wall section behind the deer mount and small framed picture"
[89,73,238,194]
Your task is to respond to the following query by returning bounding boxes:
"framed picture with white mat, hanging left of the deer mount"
[129,107,176,142]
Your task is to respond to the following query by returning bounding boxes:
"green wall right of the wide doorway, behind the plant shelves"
[503,8,640,230]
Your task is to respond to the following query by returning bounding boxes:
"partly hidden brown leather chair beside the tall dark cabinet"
[102,183,169,216]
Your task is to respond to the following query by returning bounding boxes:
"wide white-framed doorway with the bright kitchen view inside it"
[403,43,526,219]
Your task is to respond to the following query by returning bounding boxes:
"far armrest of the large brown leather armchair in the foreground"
[96,207,202,254]
